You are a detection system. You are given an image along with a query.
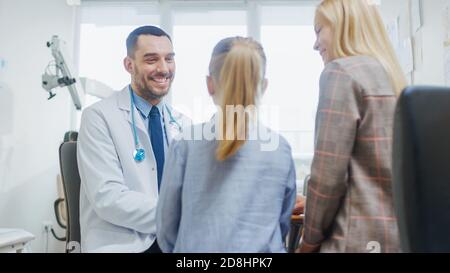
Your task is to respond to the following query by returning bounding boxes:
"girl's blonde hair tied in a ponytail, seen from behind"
[209,37,266,161]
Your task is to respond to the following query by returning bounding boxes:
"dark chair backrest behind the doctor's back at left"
[59,141,81,252]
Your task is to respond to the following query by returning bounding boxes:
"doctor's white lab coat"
[77,88,190,252]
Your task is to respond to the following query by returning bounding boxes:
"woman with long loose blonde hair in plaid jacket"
[300,0,405,252]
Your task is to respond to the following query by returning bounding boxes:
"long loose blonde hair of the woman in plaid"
[315,0,406,95]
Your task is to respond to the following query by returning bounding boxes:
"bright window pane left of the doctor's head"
[77,4,159,123]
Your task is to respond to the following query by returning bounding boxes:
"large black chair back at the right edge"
[393,86,450,253]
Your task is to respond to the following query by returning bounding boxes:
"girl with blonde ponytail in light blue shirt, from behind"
[157,37,296,252]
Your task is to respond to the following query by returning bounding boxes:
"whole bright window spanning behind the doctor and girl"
[79,0,323,186]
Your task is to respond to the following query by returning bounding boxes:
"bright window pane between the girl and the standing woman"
[261,3,323,183]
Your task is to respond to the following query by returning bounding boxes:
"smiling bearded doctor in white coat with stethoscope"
[77,26,190,253]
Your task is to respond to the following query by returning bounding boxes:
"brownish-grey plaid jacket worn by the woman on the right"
[303,56,400,252]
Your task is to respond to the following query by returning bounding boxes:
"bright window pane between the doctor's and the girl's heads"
[172,10,247,123]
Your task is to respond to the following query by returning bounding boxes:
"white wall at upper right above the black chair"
[380,0,445,85]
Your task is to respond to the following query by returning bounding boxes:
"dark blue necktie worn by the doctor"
[148,106,164,190]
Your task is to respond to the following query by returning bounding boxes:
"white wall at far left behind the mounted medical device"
[0,0,74,252]
